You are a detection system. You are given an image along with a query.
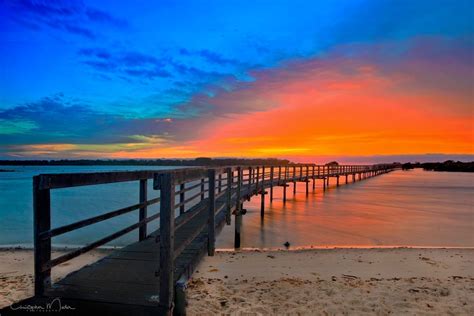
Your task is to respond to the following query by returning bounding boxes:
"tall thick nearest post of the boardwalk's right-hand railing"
[159,173,175,313]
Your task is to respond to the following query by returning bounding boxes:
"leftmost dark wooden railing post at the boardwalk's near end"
[33,176,51,296]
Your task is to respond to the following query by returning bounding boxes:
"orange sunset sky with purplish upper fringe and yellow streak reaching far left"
[7,39,474,162]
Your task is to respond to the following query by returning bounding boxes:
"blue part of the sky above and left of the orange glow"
[0,0,474,158]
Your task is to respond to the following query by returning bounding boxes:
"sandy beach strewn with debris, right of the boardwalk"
[187,248,474,315]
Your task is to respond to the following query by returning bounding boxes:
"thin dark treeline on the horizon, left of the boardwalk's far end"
[0,157,291,166]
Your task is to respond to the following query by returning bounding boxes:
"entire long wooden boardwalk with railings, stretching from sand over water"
[0,165,394,315]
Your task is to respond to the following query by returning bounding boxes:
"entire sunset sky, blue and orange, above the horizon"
[0,0,474,162]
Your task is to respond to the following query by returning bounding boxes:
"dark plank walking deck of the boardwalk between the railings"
[46,185,236,306]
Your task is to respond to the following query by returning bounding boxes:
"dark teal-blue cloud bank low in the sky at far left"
[0,95,180,145]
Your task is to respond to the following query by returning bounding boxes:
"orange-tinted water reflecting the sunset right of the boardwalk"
[217,170,474,248]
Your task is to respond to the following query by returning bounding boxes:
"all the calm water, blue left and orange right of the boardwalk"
[0,166,474,248]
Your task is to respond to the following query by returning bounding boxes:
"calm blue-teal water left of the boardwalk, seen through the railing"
[0,166,181,246]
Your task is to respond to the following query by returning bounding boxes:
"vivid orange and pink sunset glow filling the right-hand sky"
[107,50,474,160]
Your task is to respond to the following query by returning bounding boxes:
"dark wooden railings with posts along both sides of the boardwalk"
[33,165,393,306]
